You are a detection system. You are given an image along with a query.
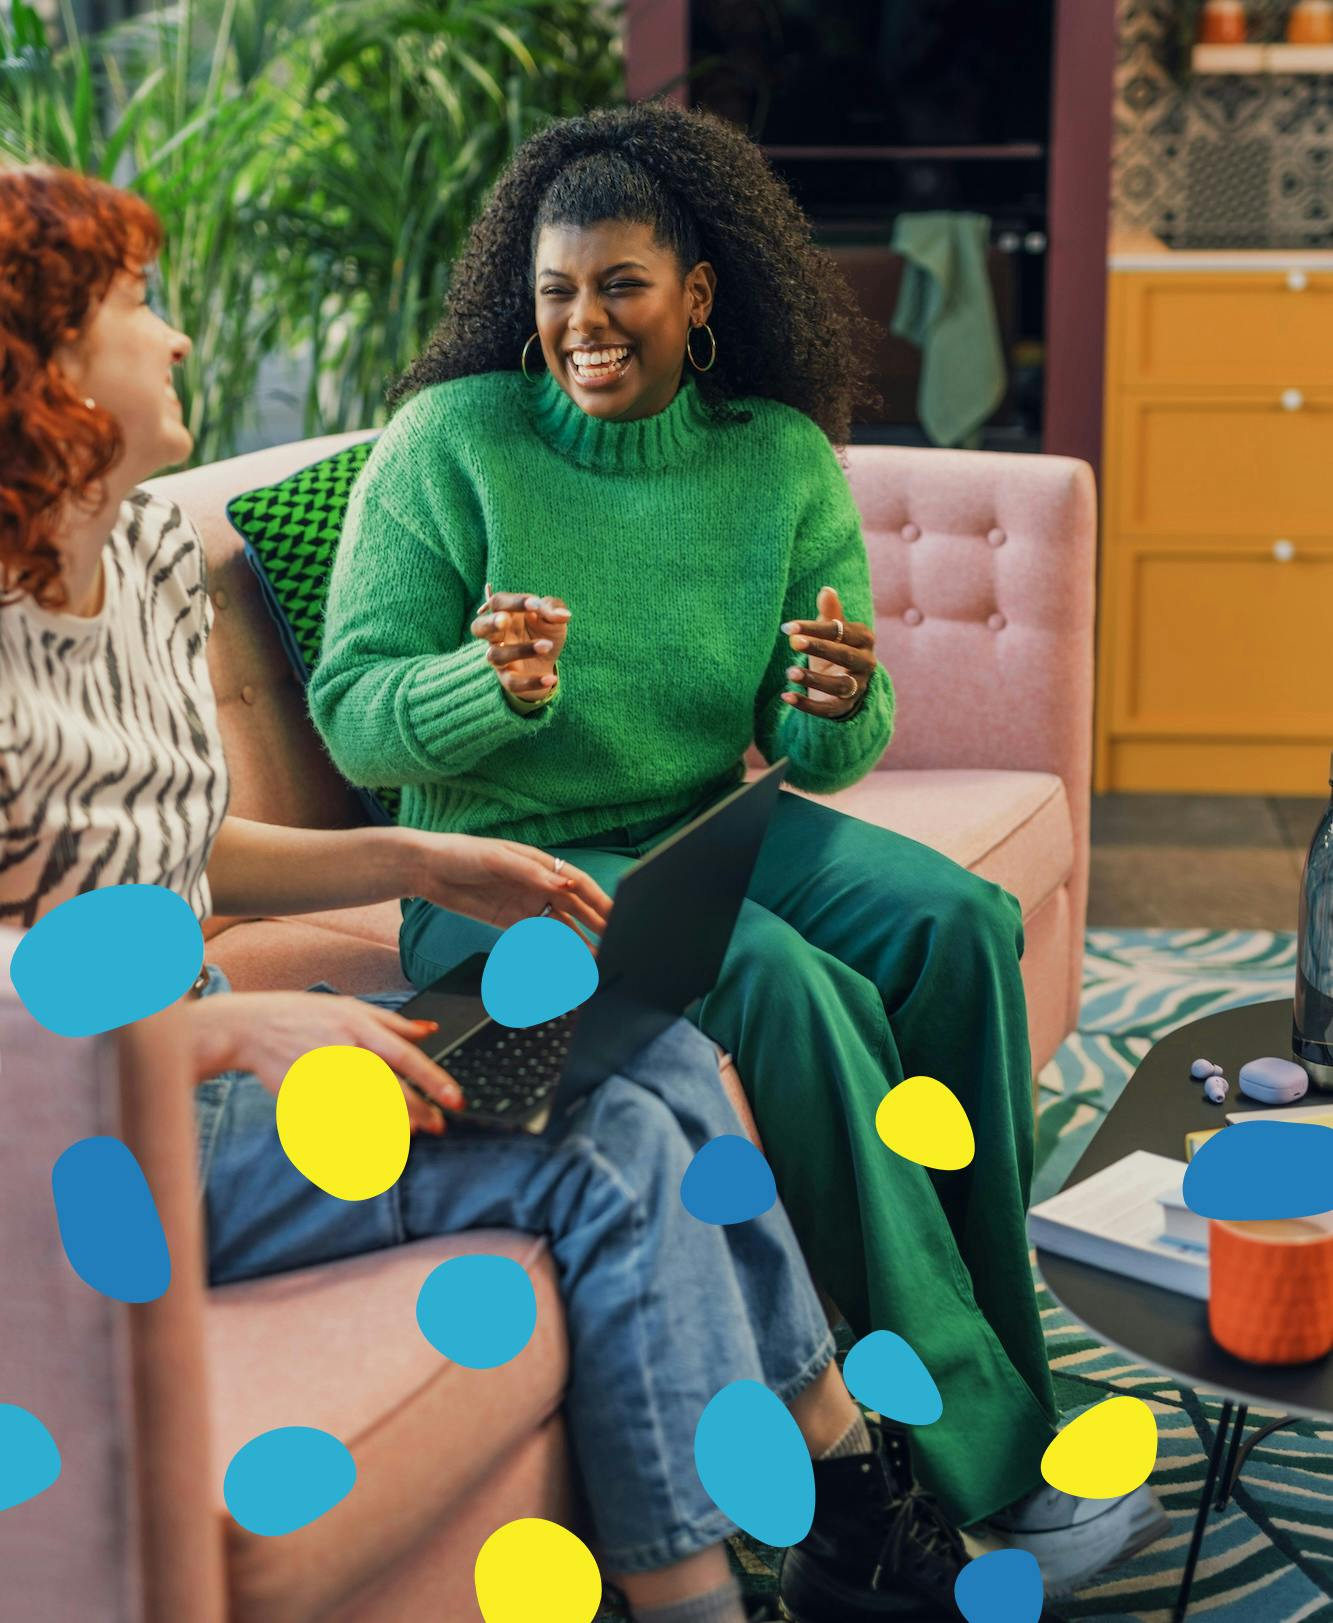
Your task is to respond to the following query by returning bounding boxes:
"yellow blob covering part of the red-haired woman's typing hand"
[278,1045,412,1201]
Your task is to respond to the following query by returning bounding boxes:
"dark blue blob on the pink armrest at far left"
[50,1138,170,1302]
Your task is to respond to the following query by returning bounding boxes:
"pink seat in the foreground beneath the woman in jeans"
[208,1230,568,1623]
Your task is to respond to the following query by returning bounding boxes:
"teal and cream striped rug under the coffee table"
[607,930,1333,1623]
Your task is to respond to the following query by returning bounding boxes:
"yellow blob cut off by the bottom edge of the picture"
[476,1516,602,1623]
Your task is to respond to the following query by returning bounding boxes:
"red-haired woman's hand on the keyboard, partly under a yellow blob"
[185,992,463,1138]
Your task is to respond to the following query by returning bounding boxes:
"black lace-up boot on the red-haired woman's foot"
[779,1422,1057,1623]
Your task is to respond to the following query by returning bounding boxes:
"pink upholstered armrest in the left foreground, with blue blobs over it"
[0,930,224,1623]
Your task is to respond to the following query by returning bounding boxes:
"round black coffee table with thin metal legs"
[1037,998,1333,1618]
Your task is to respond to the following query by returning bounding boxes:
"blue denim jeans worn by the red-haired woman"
[198,971,833,1573]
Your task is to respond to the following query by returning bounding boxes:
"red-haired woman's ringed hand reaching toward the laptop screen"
[412,834,610,935]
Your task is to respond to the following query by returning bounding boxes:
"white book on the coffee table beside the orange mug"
[1028,1149,1208,1302]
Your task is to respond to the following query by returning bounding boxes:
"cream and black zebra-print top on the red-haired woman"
[0,490,229,928]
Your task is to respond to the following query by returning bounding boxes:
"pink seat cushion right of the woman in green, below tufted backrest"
[776,768,1073,919]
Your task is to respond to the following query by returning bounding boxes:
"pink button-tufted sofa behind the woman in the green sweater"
[156,435,1096,1070]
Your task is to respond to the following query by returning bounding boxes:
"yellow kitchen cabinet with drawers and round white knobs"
[1094,260,1333,795]
